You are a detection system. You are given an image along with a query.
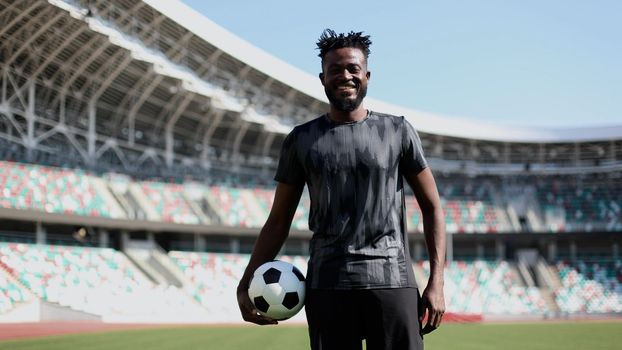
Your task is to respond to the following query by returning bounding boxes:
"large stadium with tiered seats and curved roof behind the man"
[0,0,622,348]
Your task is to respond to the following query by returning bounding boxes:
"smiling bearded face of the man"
[320,47,370,112]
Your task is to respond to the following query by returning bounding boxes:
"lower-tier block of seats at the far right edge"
[555,260,622,313]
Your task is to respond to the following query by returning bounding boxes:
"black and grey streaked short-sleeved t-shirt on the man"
[275,111,427,289]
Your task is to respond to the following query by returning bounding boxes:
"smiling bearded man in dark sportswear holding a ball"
[237,29,445,350]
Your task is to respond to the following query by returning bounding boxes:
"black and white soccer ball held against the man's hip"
[248,260,305,320]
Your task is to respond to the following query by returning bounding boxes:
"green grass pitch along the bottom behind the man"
[0,322,622,350]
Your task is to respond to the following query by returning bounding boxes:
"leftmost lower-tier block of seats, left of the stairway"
[0,243,210,322]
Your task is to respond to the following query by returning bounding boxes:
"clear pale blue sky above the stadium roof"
[183,0,622,128]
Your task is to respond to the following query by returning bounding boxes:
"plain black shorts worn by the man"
[305,288,423,350]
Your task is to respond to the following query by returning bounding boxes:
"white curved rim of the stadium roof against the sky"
[149,0,622,142]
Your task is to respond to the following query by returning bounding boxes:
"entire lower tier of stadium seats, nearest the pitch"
[0,243,622,322]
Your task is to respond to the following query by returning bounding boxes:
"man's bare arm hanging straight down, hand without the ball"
[404,167,446,334]
